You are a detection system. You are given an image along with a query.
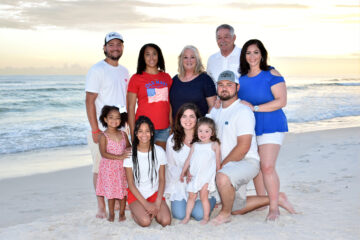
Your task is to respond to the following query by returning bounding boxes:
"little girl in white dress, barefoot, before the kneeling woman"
[180,117,221,224]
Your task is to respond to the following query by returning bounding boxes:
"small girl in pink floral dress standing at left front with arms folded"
[96,106,131,222]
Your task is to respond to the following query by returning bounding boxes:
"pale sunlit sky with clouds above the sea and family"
[0,0,360,76]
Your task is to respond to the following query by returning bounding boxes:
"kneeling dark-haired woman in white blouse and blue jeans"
[165,103,216,221]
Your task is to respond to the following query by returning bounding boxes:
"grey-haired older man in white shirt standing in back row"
[206,24,241,84]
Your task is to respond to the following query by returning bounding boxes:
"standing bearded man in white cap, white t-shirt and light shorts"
[85,32,129,218]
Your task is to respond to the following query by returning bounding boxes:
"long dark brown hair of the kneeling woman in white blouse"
[173,103,201,151]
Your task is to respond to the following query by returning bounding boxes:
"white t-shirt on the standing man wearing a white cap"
[85,60,129,130]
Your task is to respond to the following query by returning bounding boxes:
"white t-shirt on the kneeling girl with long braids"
[124,145,167,199]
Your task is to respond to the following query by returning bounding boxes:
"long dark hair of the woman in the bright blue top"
[239,39,270,76]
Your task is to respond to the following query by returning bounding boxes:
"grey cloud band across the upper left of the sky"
[0,0,190,29]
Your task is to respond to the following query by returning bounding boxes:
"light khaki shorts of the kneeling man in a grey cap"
[219,158,260,211]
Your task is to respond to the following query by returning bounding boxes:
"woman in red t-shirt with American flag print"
[127,43,172,149]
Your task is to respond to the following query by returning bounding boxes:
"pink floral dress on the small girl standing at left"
[96,131,127,199]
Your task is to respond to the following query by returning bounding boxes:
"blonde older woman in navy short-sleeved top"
[170,45,216,119]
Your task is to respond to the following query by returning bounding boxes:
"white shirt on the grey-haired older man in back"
[206,46,241,85]
